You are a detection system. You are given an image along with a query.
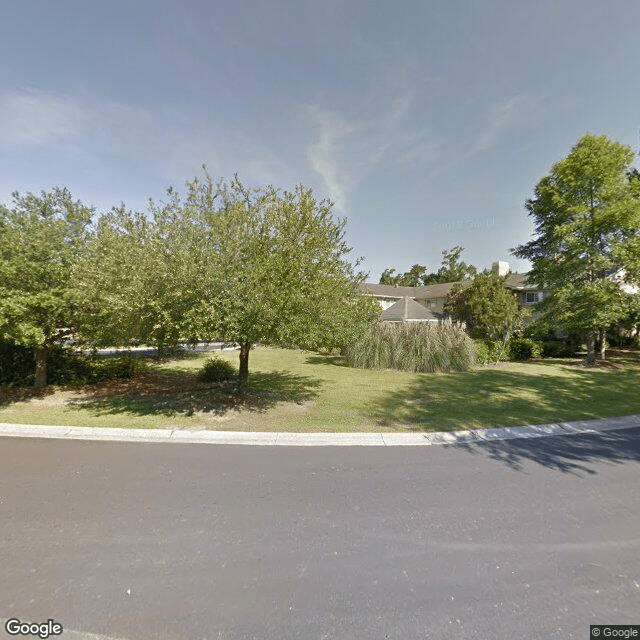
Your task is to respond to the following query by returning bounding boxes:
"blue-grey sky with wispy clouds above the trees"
[0,0,640,282]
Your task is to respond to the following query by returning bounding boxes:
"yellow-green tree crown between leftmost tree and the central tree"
[76,199,209,351]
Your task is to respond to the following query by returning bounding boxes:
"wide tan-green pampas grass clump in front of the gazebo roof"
[346,321,475,373]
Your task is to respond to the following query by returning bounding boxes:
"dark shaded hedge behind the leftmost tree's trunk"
[0,342,148,387]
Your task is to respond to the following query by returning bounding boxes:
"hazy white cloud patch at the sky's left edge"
[0,89,93,149]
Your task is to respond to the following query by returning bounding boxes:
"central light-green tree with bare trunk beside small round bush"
[178,175,374,388]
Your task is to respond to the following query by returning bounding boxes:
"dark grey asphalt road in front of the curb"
[0,429,640,640]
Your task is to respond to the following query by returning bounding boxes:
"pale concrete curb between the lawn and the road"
[0,415,640,447]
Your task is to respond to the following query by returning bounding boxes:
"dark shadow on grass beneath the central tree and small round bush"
[69,371,322,416]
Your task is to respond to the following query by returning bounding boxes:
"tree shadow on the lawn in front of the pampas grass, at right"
[370,361,640,431]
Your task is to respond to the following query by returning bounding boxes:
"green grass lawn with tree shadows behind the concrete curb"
[0,347,640,432]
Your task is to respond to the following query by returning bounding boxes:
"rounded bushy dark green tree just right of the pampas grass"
[443,273,526,344]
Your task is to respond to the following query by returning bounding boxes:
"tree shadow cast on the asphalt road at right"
[448,428,640,476]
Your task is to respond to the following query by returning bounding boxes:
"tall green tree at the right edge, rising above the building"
[512,134,640,362]
